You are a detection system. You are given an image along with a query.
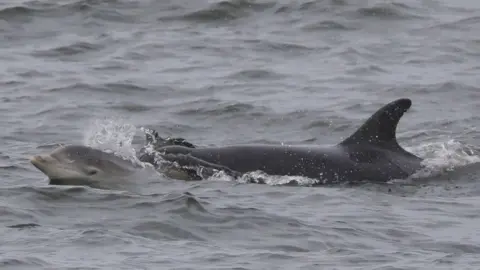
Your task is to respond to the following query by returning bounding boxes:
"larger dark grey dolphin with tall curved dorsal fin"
[147,98,422,183]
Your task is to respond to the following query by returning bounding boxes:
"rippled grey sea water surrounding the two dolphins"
[0,0,480,270]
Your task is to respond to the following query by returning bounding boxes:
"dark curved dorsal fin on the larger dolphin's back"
[340,98,412,150]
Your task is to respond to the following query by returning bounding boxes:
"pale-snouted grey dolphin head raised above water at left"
[30,145,135,186]
